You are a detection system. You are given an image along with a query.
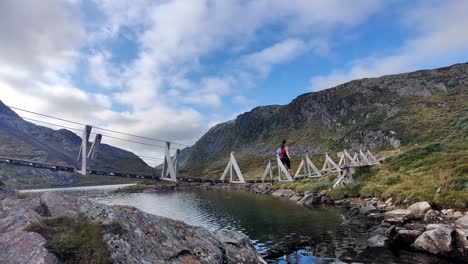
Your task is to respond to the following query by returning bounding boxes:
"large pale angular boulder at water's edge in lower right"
[414,227,453,255]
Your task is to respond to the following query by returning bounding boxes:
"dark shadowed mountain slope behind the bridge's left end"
[0,101,153,186]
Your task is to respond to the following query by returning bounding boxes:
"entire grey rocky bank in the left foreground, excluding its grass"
[0,183,266,263]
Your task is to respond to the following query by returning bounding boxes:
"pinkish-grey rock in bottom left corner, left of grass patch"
[0,230,59,264]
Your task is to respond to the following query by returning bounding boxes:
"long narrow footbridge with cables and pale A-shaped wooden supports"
[0,107,379,188]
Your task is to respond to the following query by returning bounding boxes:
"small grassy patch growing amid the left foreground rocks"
[26,216,114,264]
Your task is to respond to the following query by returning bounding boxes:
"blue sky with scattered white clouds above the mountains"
[0,0,468,163]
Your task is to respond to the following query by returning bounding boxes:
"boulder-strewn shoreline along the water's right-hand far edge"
[132,183,468,263]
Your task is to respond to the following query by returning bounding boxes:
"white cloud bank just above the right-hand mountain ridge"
[310,1,468,91]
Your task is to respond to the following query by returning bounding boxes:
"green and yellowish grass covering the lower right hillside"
[185,81,468,208]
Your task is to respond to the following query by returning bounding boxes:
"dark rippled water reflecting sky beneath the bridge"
[91,190,447,264]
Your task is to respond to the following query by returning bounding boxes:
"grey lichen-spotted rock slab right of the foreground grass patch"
[78,199,264,263]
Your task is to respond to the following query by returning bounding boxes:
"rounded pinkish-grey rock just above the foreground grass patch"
[40,192,78,217]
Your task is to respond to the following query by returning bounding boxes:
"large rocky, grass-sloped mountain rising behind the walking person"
[182,63,468,207]
